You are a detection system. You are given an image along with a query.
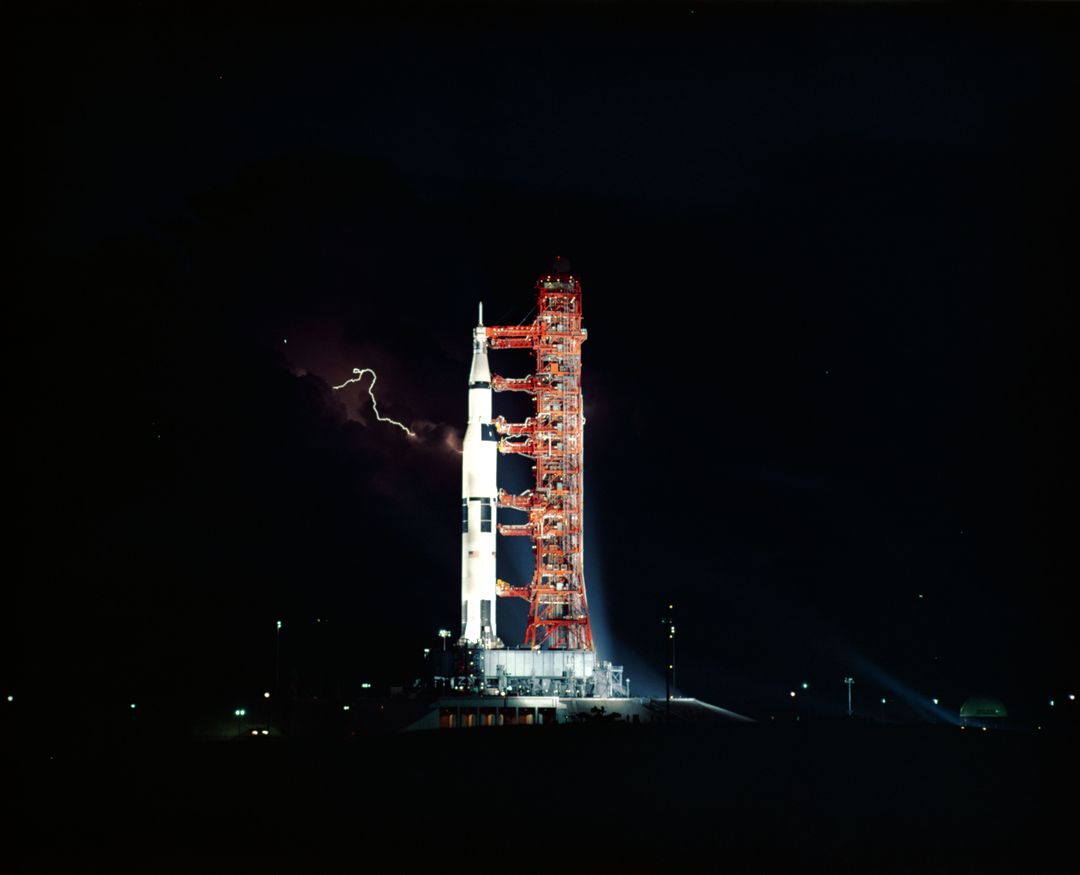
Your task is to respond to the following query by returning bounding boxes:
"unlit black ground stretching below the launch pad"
[5,723,1077,873]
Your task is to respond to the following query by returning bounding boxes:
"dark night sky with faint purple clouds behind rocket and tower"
[12,3,1080,716]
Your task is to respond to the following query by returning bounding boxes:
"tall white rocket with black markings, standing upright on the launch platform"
[461,307,502,647]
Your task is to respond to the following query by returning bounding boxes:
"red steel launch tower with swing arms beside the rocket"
[487,259,593,650]
